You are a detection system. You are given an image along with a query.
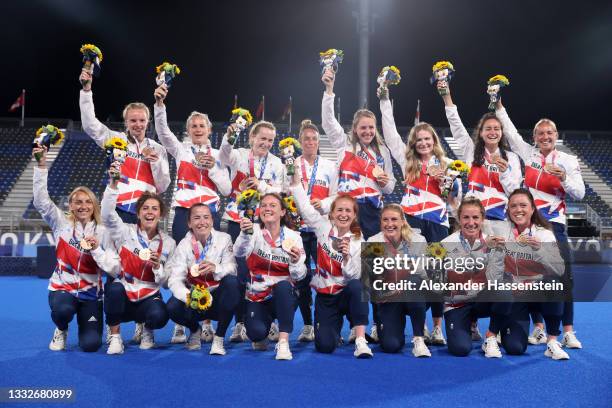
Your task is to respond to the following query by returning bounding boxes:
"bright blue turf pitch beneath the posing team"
[0,277,612,408]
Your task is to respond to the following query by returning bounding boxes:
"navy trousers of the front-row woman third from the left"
[167,275,240,337]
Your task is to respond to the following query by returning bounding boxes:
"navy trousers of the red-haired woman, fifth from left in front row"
[314,279,369,353]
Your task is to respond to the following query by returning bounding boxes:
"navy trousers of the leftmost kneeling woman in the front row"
[49,291,103,352]
